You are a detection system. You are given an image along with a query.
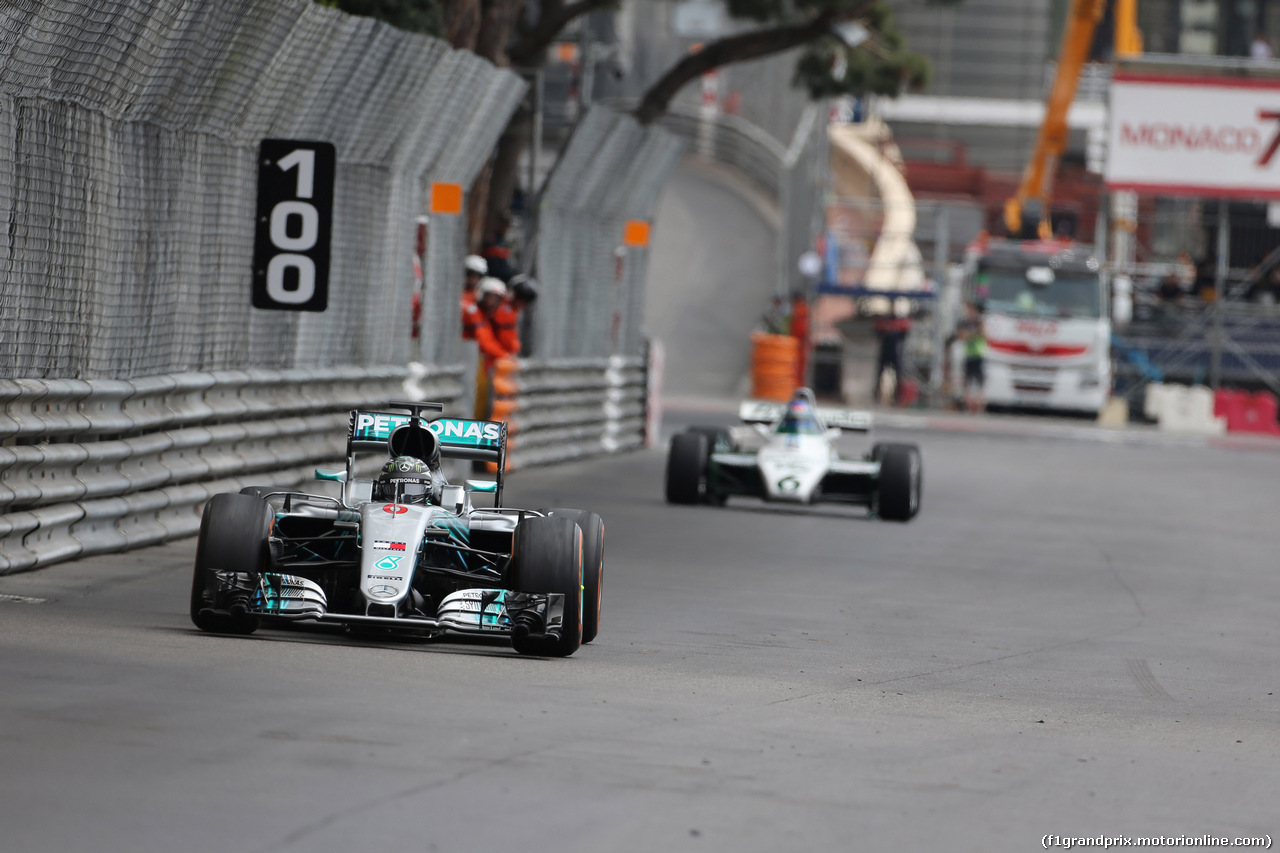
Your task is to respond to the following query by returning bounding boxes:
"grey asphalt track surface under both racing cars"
[0,412,1280,853]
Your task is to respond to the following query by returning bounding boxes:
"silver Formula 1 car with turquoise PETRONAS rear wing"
[191,402,604,657]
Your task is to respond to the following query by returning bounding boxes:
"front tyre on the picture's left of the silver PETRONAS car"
[191,493,275,634]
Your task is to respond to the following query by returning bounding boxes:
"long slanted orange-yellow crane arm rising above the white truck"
[1005,0,1107,240]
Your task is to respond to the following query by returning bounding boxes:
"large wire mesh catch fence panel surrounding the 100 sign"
[0,0,525,379]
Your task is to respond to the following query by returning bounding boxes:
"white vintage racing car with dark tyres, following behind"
[667,388,923,521]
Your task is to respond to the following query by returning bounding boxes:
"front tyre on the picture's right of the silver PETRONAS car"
[511,516,582,657]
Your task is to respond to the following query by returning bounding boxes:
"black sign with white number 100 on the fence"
[253,140,334,311]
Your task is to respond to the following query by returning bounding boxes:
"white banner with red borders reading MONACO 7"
[1106,73,1280,199]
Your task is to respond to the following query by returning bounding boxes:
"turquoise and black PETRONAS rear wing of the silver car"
[347,402,507,506]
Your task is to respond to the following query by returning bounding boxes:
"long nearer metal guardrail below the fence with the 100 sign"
[0,368,462,575]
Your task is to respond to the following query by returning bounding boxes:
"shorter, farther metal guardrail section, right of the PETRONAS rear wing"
[493,356,649,470]
